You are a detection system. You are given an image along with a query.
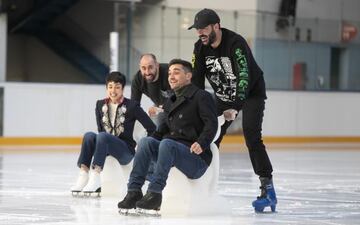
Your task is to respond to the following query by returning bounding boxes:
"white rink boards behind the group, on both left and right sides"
[0,83,360,137]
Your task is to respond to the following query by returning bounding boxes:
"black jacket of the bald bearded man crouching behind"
[131,64,170,106]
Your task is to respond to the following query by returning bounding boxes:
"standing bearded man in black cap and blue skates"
[188,9,277,212]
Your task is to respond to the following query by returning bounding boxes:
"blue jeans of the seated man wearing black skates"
[128,137,208,193]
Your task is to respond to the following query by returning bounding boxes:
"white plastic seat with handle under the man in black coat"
[161,116,230,215]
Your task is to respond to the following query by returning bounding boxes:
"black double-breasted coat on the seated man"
[153,84,218,165]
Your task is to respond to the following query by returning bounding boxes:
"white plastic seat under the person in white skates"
[100,155,133,198]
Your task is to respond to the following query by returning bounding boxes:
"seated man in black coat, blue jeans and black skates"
[118,59,218,214]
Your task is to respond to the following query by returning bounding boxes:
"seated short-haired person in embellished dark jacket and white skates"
[71,72,156,193]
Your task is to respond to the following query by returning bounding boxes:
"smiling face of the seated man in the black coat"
[168,64,192,91]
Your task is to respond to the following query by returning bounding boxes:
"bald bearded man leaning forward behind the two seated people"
[131,53,170,117]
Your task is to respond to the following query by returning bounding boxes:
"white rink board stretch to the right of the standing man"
[263,91,360,137]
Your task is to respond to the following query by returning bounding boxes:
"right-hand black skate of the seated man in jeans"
[136,191,162,216]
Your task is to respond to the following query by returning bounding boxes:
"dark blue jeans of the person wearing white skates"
[77,132,134,168]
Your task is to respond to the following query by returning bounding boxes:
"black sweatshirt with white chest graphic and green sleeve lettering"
[192,28,266,110]
